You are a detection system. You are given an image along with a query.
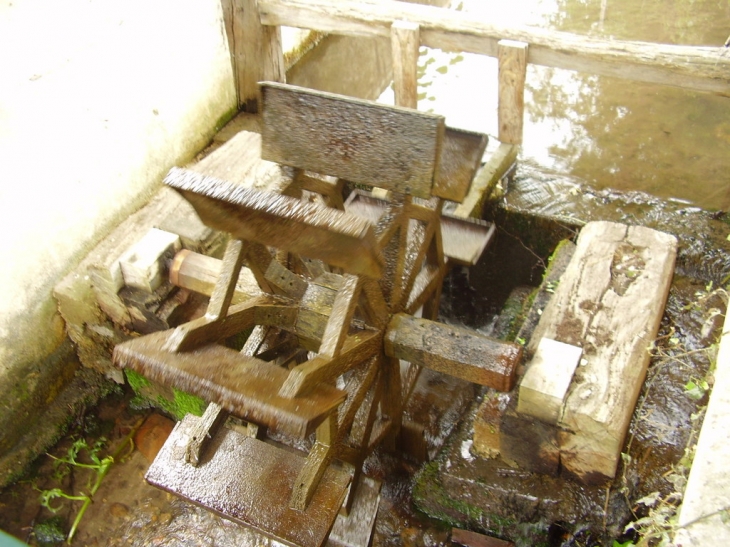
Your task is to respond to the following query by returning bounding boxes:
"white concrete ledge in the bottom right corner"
[674,306,730,547]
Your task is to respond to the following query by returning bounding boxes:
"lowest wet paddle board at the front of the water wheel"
[145,415,350,547]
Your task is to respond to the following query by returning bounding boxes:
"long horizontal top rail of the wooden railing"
[259,0,730,95]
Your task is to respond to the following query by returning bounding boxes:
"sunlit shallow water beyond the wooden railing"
[384,0,730,210]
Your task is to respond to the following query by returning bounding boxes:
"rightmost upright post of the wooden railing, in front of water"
[497,40,527,144]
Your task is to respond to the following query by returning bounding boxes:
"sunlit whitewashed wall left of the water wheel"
[0,0,235,462]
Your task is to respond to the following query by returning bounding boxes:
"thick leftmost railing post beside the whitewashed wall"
[229,0,286,113]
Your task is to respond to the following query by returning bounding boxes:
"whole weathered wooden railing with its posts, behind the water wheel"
[222,0,730,214]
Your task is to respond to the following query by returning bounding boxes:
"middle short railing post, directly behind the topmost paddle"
[390,21,421,108]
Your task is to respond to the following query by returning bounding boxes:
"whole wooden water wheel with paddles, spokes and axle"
[114,83,521,547]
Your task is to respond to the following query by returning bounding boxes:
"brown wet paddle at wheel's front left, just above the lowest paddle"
[113,330,346,438]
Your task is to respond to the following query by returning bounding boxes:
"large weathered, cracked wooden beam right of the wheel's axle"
[528,222,677,482]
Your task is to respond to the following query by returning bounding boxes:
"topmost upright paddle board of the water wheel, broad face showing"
[261,82,444,198]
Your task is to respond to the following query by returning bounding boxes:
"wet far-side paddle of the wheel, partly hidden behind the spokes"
[345,192,495,266]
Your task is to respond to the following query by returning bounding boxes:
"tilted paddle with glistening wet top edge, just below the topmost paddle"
[165,168,383,278]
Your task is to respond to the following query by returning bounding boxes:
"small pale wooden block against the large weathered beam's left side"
[517,338,583,425]
